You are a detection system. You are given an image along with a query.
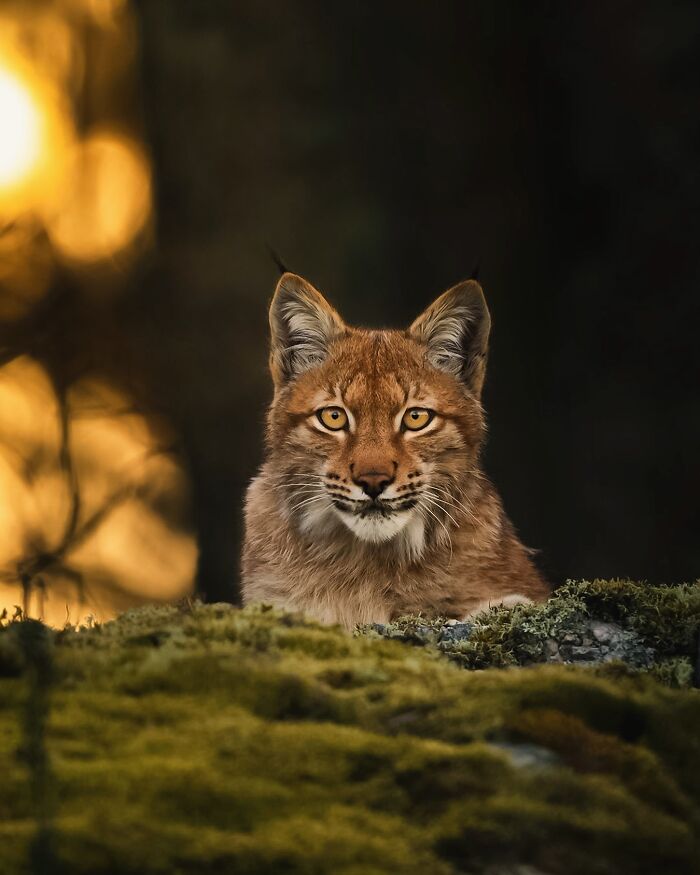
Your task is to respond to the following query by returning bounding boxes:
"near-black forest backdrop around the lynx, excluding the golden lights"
[79,0,700,598]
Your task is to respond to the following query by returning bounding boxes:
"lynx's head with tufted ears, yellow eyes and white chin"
[268,273,490,558]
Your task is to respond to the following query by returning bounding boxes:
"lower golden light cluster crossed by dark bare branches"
[0,356,197,626]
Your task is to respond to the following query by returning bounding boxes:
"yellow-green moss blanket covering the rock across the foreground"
[0,582,700,875]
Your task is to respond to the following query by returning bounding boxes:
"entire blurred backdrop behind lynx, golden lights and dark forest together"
[0,0,700,625]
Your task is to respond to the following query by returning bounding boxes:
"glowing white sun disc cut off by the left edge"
[0,68,42,188]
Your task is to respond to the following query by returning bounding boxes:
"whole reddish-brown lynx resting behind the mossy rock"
[242,273,548,628]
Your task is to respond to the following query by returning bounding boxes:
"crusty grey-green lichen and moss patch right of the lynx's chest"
[360,580,700,686]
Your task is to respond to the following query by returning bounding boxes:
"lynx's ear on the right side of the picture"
[409,280,491,398]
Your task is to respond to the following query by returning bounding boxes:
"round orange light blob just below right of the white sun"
[49,132,151,262]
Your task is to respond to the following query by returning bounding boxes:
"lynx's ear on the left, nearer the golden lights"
[270,273,346,385]
